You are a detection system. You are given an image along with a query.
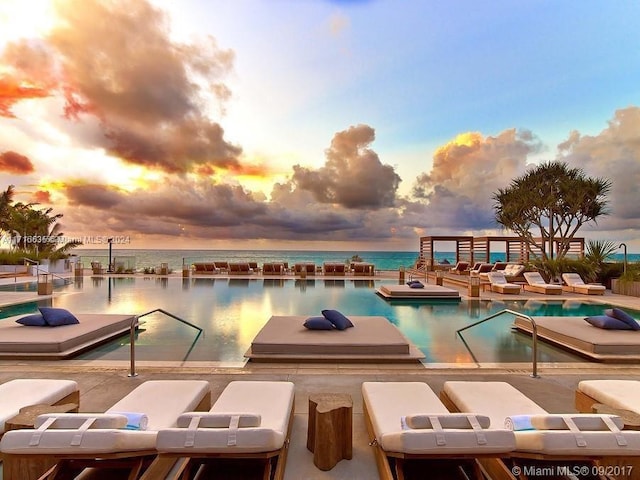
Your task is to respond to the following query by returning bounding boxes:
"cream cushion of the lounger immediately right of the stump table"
[362,382,515,456]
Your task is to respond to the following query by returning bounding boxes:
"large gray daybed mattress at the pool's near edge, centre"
[245,316,424,360]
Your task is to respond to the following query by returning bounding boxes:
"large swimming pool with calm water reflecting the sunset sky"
[0,276,624,363]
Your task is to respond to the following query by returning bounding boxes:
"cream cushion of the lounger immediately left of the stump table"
[157,381,294,454]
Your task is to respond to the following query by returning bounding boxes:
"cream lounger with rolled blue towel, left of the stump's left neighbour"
[0,380,211,480]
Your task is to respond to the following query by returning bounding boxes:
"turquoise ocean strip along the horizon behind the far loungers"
[74,246,640,271]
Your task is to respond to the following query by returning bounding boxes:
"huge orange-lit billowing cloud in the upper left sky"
[0,0,242,173]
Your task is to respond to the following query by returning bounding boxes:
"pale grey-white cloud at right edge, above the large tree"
[558,107,640,230]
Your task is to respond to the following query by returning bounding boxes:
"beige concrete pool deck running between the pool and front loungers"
[0,272,640,480]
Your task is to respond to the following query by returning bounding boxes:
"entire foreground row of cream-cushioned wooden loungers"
[7,380,640,480]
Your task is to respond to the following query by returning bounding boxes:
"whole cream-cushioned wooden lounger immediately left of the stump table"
[152,381,294,480]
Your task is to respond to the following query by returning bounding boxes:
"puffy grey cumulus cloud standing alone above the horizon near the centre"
[292,125,400,209]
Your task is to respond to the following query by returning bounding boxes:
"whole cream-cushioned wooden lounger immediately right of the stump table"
[362,382,515,479]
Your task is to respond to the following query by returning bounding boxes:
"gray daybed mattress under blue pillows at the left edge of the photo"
[0,313,134,358]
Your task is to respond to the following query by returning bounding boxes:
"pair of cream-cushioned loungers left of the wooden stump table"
[0,380,294,480]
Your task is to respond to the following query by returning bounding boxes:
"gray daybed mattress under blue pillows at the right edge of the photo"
[514,317,640,361]
